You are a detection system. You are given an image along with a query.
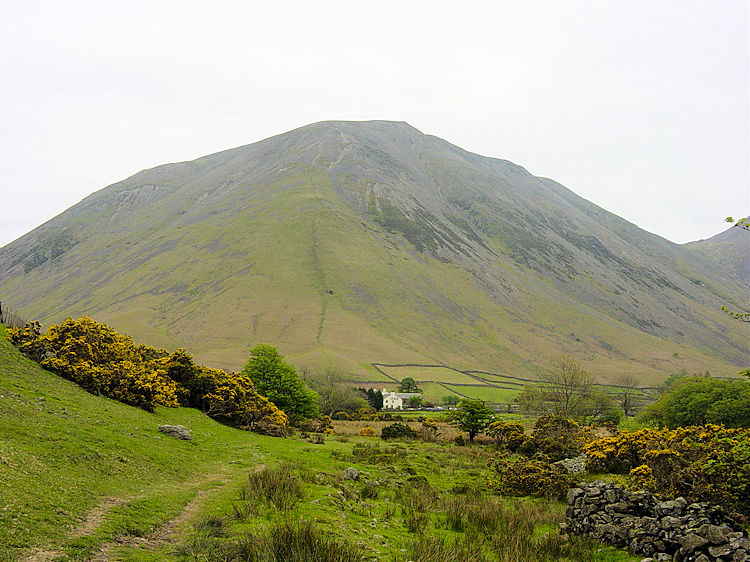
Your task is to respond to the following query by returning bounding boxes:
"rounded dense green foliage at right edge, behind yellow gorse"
[643,377,750,429]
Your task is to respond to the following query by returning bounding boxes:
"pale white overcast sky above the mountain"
[0,0,750,246]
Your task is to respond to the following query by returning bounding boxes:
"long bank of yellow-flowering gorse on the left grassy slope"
[8,317,288,430]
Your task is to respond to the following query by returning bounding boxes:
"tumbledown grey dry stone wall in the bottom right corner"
[561,481,750,562]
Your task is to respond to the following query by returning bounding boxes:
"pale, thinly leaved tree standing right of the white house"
[518,355,594,419]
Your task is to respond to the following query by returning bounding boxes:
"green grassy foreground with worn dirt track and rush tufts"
[0,328,631,562]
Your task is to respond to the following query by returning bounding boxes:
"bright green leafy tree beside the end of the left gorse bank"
[242,343,318,425]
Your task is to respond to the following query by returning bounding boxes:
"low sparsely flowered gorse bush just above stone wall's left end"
[487,457,575,498]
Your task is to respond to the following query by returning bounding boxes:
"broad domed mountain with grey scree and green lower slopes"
[0,121,750,383]
